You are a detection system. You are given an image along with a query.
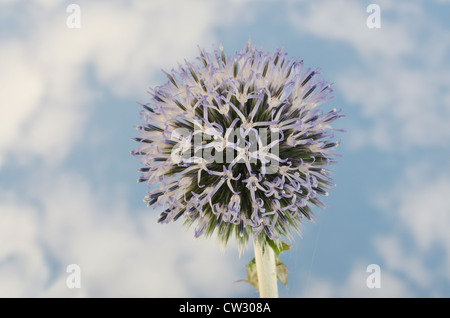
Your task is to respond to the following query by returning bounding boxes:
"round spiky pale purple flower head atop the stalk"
[132,43,342,251]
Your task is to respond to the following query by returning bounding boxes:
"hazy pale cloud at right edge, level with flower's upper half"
[337,63,450,150]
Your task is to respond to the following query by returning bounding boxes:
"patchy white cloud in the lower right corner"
[299,158,450,297]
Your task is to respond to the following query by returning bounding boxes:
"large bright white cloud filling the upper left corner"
[0,1,246,169]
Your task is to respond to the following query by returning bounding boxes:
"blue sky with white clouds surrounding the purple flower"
[0,0,450,297]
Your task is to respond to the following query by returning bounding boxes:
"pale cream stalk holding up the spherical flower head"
[253,238,278,298]
